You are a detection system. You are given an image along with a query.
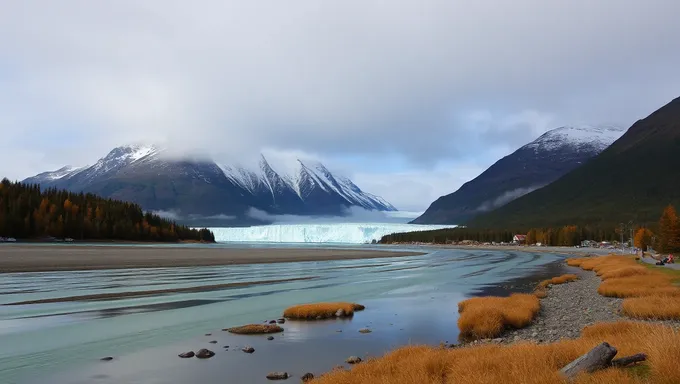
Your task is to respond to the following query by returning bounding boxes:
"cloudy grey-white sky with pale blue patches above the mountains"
[0,0,680,211]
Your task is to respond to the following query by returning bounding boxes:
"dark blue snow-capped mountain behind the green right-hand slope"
[412,126,623,224]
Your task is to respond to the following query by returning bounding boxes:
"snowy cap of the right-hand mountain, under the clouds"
[525,125,625,152]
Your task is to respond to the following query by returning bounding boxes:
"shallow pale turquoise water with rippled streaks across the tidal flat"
[0,244,560,383]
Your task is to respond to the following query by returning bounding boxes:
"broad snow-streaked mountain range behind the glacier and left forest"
[23,145,396,225]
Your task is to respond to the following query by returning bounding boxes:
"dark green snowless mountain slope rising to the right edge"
[468,98,680,228]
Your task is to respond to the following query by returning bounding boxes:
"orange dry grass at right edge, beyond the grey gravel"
[567,255,680,320]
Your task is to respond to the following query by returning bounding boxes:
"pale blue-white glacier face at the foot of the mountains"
[210,223,456,244]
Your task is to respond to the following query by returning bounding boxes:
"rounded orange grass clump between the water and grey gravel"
[458,293,541,339]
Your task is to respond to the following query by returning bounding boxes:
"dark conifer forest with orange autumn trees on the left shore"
[0,179,215,242]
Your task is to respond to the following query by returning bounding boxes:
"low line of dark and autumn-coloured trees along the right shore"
[379,205,680,253]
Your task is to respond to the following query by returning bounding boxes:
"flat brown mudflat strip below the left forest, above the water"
[0,244,424,273]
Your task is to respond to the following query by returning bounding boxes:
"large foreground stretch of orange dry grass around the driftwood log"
[314,322,680,384]
